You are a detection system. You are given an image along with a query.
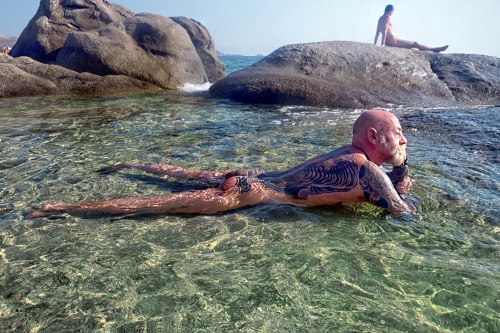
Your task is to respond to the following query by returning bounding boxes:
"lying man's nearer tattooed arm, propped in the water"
[359,161,416,213]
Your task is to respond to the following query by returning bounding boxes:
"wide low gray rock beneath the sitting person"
[210,42,500,108]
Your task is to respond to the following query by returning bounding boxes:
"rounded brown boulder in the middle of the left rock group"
[56,14,208,89]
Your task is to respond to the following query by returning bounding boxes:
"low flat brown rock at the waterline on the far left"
[0,54,159,98]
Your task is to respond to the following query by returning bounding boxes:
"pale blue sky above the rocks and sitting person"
[0,0,500,57]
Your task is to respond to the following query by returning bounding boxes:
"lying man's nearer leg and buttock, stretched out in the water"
[26,177,271,219]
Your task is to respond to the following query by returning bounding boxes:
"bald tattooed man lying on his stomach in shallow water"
[26,110,416,218]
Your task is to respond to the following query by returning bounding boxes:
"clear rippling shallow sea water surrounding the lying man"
[0,92,500,332]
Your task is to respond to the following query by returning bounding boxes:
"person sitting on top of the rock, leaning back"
[374,5,448,52]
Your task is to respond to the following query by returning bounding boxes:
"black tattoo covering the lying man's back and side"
[258,156,358,199]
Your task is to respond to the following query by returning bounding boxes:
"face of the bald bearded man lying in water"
[380,117,407,165]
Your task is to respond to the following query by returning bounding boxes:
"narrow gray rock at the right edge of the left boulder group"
[171,17,226,82]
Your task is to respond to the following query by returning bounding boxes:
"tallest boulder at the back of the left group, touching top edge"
[10,0,134,63]
